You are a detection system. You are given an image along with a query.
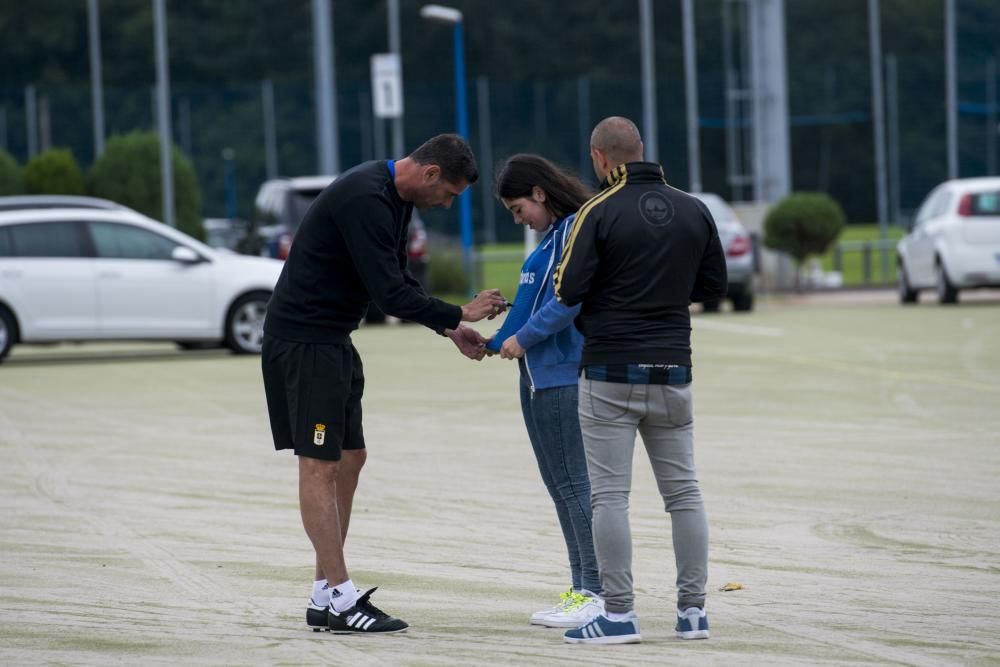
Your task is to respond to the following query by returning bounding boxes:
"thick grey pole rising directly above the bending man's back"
[312,0,340,175]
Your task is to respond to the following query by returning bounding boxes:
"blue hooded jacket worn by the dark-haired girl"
[486,215,583,389]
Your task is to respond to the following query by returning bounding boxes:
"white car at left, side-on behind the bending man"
[0,208,283,359]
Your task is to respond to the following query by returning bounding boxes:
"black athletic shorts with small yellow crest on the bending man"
[261,334,365,461]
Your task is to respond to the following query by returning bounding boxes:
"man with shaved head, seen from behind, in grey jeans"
[555,117,726,643]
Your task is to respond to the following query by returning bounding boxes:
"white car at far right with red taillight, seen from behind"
[896,178,1000,303]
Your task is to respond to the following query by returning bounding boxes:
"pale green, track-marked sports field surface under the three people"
[0,293,1000,666]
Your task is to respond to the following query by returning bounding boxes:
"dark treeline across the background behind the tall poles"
[0,0,1000,237]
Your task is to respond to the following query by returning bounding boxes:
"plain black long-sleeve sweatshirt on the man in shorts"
[264,160,462,343]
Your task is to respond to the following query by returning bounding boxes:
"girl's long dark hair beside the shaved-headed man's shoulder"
[496,153,593,219]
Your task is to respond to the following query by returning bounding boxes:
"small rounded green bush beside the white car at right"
[764,192,846,266]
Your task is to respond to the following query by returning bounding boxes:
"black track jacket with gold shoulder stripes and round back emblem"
[555,162,726,366]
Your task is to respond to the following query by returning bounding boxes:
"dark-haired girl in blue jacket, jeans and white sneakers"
[486,154,604,628]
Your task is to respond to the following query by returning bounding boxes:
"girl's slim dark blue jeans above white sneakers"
[521,376,601,593]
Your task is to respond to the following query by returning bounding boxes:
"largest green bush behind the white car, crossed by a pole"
[89,132,205,239]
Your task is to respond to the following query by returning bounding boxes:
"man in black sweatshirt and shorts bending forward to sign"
[261,134,505,633]
